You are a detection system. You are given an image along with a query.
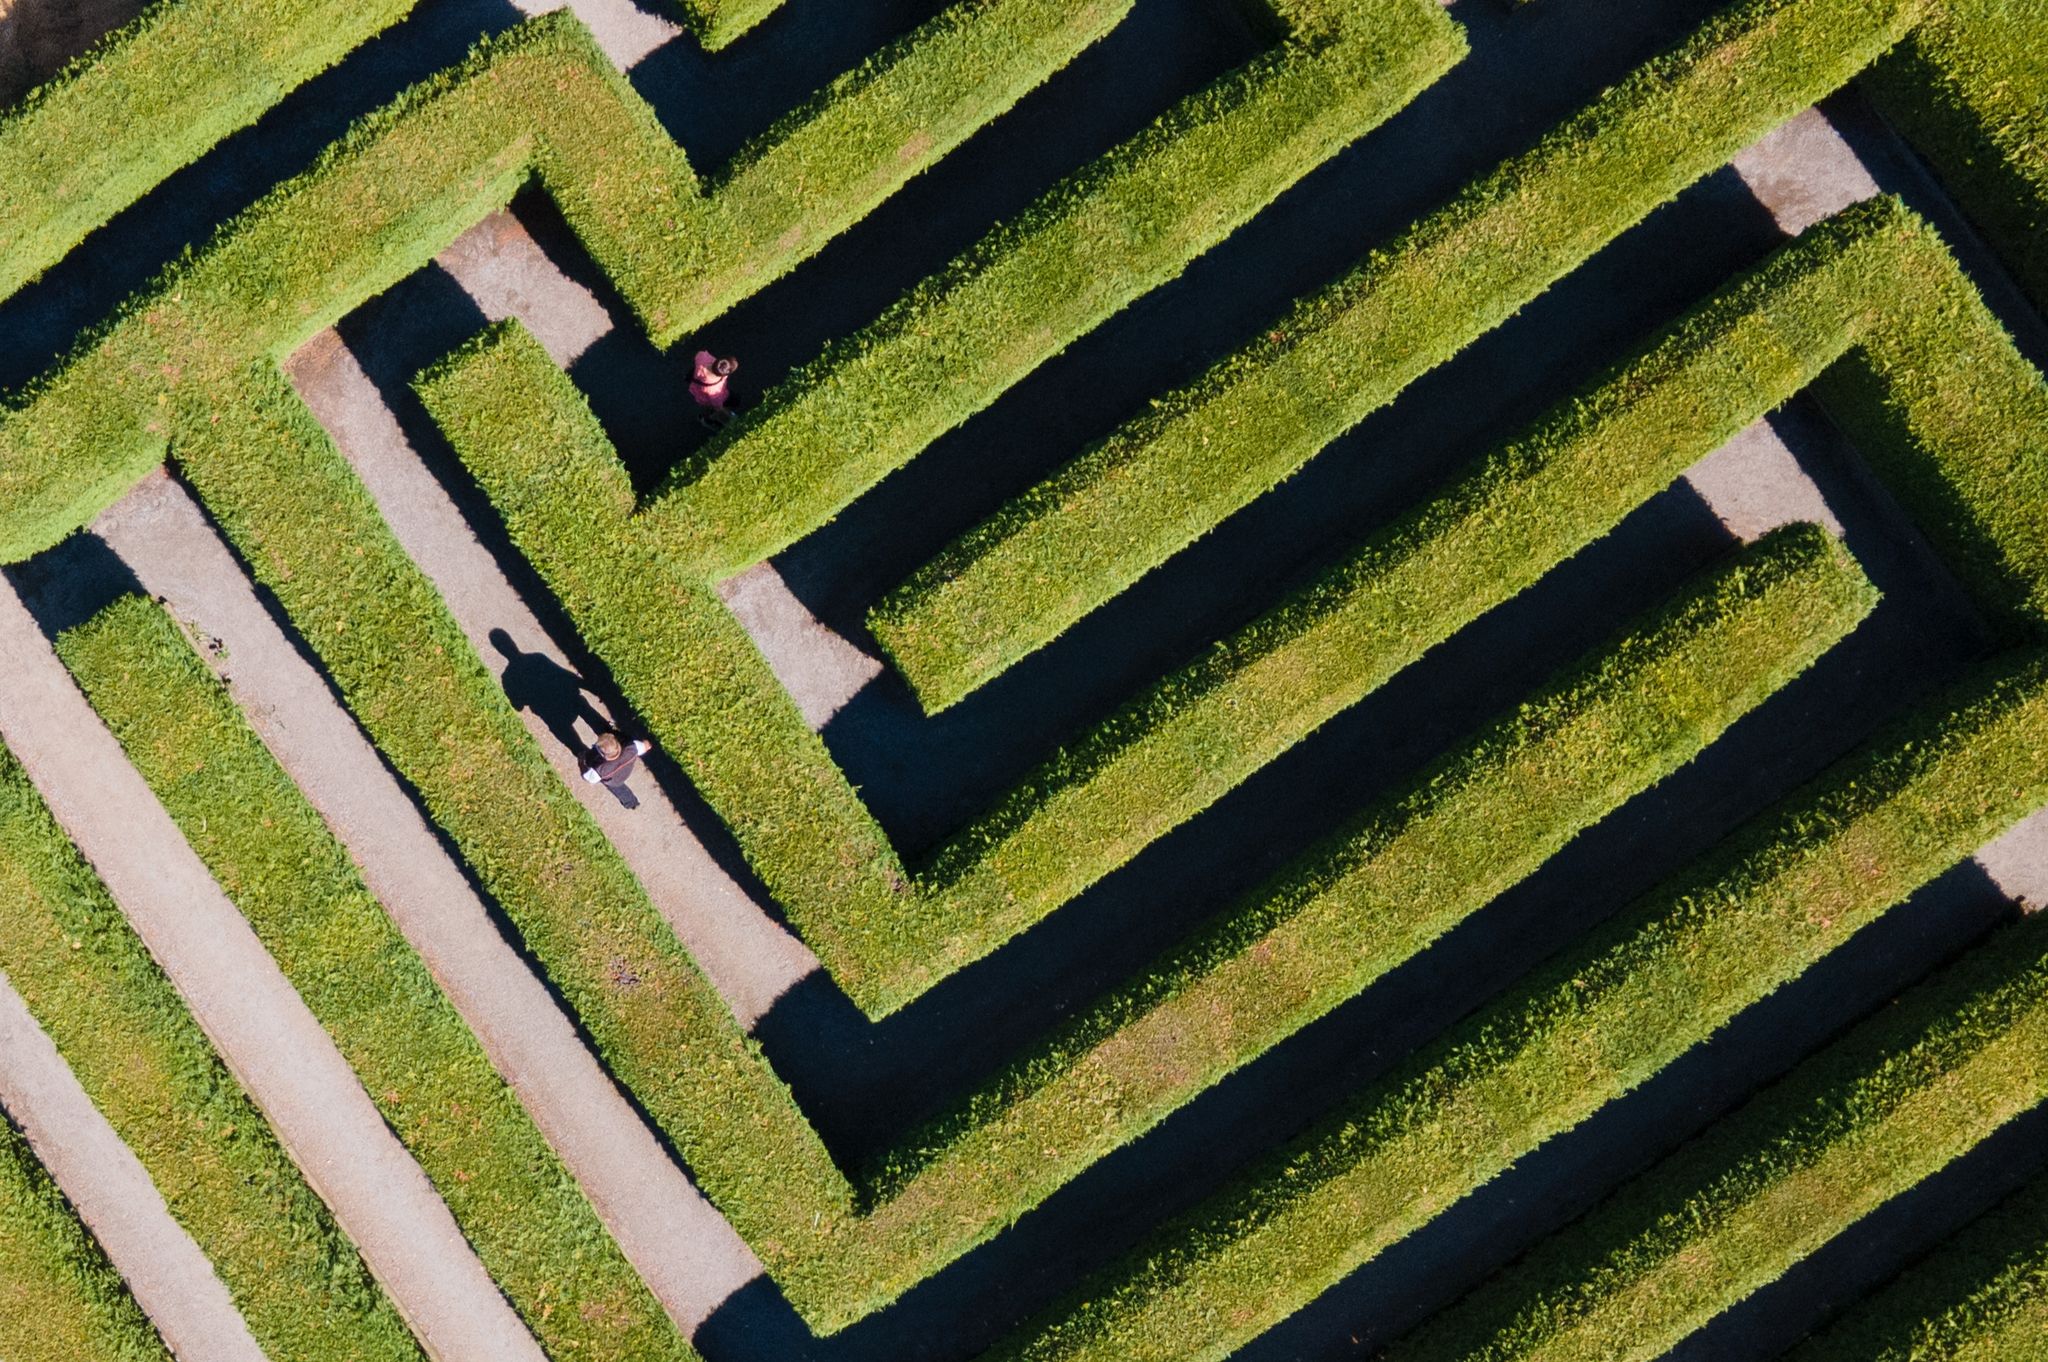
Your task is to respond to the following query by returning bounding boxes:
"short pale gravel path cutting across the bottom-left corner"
[0,975,264,1362]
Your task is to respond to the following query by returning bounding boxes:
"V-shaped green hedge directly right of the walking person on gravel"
[420,205,1903,1012]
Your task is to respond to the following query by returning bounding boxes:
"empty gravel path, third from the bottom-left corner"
[92,473,762,1331]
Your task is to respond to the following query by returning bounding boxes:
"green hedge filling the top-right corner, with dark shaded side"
[1868,0,2048,307]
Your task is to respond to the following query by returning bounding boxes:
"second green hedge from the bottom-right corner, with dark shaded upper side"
[1384,909,2048,1362]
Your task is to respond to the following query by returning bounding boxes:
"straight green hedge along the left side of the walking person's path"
[167,365,852,1309]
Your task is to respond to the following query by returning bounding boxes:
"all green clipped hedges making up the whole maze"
[0,0,2048,1362]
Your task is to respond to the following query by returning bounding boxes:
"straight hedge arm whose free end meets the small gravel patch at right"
[835,526,1876,1294]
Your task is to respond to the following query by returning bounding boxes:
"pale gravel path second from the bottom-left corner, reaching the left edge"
[0,584,545,1362]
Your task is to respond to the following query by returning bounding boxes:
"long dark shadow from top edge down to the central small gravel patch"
[770,0,1744,655]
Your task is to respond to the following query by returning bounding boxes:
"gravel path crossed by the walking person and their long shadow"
[289,332,819,1028]
